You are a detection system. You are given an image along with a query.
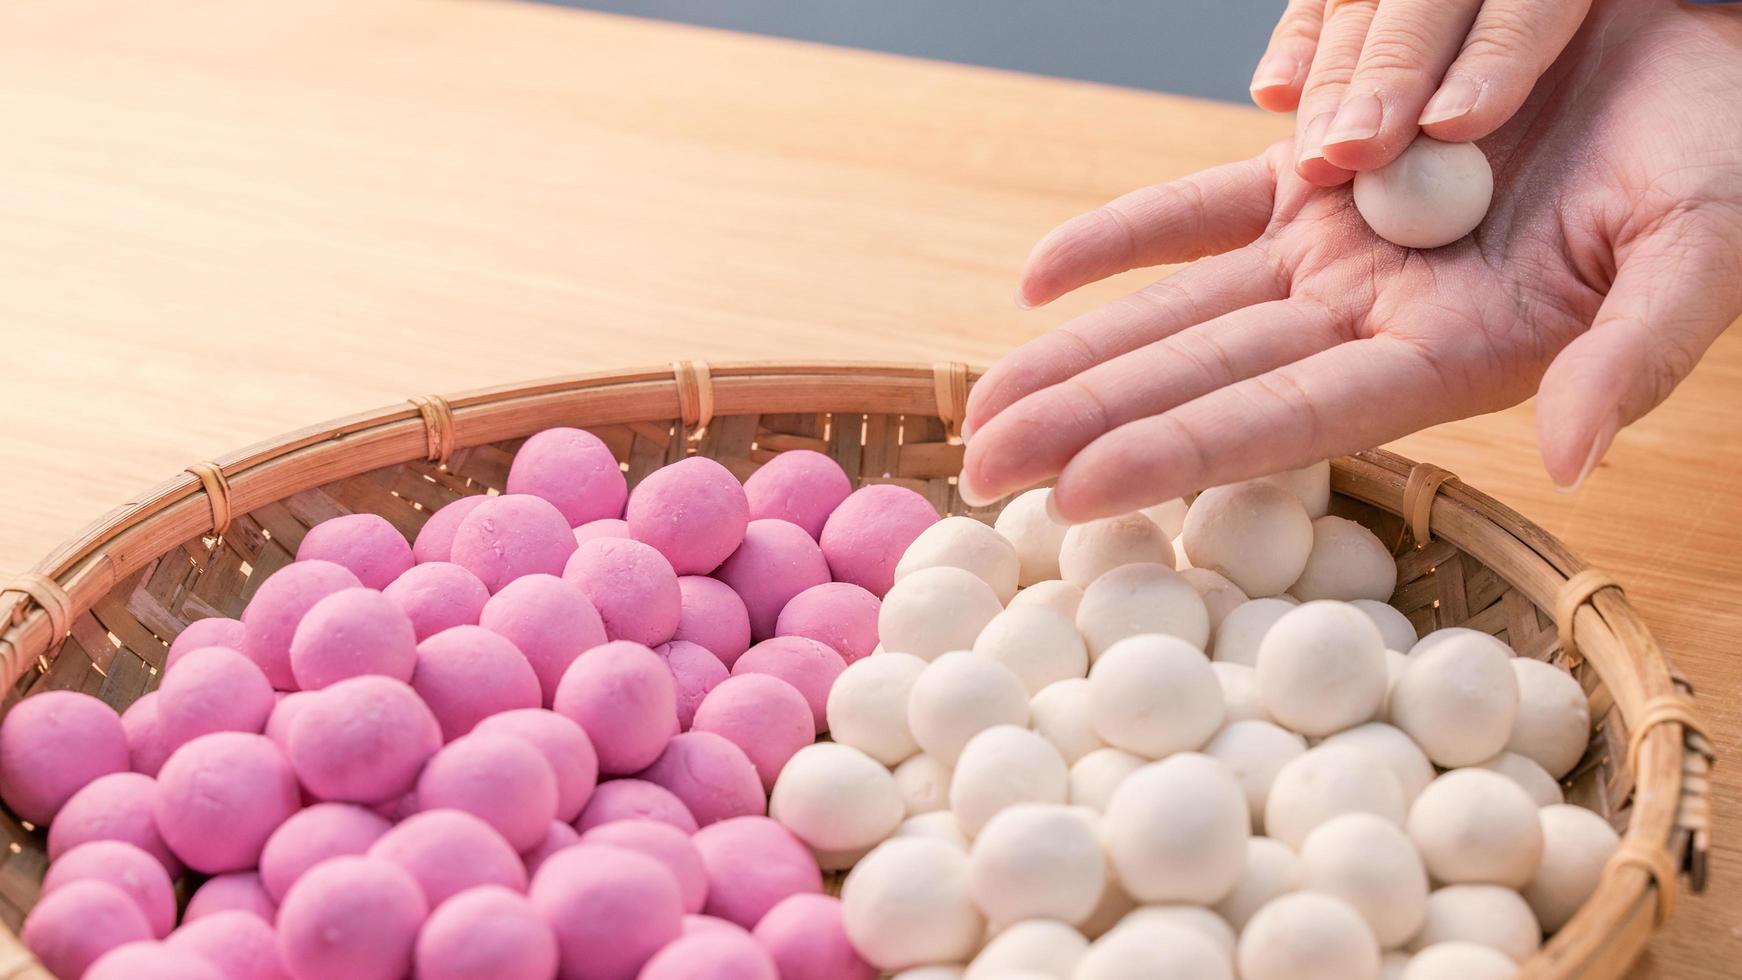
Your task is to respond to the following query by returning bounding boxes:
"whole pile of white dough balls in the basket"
[783,463,1618,980]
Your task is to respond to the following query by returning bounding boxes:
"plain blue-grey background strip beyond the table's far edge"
[552,0,1282,103]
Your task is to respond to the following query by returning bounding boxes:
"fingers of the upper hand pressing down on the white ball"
[1252,0,1590,186]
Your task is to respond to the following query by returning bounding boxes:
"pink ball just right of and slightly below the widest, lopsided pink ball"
[418,733,556,851]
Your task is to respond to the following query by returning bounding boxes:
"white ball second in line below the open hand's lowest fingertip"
[1077,564,1209,660]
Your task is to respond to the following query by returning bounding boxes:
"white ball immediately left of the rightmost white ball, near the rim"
[1409,769,1542,888]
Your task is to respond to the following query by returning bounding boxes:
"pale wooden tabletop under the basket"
[0,0,1742,978]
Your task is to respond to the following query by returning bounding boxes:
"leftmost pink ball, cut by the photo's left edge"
[0,689,128,827]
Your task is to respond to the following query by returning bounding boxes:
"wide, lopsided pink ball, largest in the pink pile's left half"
[286,677,441,806]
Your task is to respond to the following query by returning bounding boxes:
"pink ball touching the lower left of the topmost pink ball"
[449,493,575,594]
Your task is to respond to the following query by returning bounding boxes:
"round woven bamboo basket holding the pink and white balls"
[0,362,1712,980]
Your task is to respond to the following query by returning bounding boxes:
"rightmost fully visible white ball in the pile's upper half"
[1390,635,1519,768]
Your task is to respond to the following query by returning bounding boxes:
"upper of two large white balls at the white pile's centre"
[1089,635,1225,759]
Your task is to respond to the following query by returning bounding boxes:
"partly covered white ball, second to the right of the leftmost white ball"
[949,724,1070,837]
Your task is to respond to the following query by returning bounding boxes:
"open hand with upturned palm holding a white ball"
[962,0,1742,520]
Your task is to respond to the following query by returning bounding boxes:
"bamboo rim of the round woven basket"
[0,360,1711,977]
